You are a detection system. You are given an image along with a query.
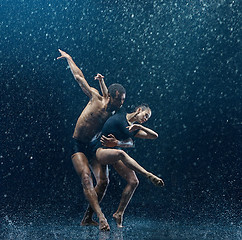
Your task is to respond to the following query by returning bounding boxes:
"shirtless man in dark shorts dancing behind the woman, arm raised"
[57,49,125,231]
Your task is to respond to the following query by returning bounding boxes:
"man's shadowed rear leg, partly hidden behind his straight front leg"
[82,159,109,225]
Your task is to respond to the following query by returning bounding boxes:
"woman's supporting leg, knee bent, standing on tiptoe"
[113,161,139,227]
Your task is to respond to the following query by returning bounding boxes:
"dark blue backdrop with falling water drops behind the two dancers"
[0,0,242,219]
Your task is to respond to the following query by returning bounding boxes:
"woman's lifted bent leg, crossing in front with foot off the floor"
[96,148,164,187]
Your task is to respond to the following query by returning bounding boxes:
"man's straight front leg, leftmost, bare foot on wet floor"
[72,152,110,231]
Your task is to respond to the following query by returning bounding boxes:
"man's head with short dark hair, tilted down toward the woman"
[108,83,126,110]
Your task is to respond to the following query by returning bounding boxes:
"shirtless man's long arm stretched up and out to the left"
[57,49,93,98]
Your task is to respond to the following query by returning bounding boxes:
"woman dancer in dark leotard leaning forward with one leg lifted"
[95,104,164,227]
